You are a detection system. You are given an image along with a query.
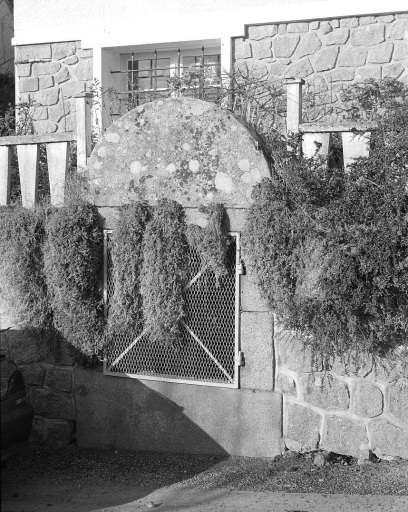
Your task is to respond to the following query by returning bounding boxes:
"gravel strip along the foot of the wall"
[2,446,408,495]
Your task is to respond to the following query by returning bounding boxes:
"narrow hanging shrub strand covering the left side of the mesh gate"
[108,203,151,336]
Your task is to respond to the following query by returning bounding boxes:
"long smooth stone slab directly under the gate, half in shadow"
[75,367,282,457]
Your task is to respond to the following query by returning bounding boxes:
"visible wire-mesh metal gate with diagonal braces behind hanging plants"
[104,231,241,388]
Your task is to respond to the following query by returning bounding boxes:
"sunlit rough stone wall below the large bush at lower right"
[275,324,408,459]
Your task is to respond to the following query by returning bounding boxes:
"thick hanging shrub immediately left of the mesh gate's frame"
[44,204,103,356]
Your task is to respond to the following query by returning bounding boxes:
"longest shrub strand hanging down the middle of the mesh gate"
[140,199,188,346]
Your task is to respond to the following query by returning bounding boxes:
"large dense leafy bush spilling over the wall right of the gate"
[244,81,408,369]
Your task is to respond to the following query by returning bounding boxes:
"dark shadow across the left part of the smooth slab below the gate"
[75,368,228,456]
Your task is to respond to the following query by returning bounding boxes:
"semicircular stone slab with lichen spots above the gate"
[89,98,270,208]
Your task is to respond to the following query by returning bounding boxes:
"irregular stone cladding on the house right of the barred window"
[233,14,408,92]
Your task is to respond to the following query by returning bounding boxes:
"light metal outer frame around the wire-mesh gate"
[103,229,243,389]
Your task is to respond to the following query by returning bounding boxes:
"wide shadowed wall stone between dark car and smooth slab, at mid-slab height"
[31,388,75,420]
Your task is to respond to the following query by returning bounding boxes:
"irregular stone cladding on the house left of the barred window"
[15,41,93,134]
